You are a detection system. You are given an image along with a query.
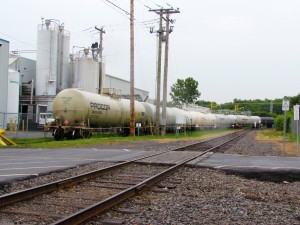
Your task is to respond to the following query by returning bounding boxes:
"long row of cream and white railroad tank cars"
[44,88,261,140]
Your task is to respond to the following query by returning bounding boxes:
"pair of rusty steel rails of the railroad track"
[0,129,248,224]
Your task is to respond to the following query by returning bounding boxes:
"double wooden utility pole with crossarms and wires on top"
[149,9,179,135]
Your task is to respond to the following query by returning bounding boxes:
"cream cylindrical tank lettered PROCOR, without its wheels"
[52,89,145,128]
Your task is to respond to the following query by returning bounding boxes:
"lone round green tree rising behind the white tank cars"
[170,77,201,104]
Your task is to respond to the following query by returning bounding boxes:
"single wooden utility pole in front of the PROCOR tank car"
[130,0,135,136]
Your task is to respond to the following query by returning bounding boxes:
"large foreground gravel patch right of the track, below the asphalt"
[95,168,300,225]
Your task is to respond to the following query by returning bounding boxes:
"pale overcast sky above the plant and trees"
[0,0,300,104]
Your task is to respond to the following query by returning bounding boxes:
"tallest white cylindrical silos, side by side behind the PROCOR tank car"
[36,20,70,96]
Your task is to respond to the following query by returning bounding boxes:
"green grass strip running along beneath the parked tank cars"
[1,130,229,148]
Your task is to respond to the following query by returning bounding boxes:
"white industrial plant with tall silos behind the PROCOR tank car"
[0,19,149,129]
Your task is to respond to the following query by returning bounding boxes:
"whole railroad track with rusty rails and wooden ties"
[0,131,245,224]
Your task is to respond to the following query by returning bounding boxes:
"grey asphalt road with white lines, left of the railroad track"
[0,148,145,184]
